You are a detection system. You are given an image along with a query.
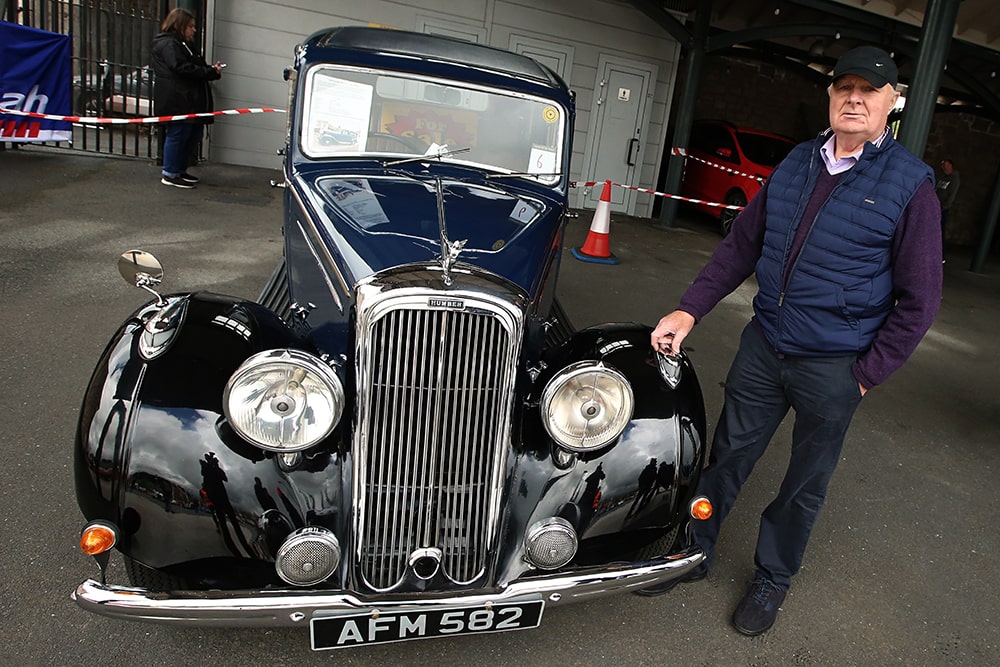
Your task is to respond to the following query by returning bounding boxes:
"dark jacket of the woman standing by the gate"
[149,32,220,123]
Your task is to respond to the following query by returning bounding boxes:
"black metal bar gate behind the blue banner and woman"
[0,0,170,158]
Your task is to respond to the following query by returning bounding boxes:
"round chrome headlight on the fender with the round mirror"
[222,350,344,452]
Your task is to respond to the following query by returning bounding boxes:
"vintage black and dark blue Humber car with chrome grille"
[74,27,710,649]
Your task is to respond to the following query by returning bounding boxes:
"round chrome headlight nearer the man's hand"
[542,361,635,452]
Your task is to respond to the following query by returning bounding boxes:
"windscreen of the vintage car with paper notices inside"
[300,66,567,183]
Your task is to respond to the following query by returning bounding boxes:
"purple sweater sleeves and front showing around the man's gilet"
[678,170,942,389]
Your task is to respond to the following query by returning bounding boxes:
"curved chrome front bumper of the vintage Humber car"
[72,547,705,627]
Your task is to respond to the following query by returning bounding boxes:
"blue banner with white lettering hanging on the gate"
[0,21,73,141]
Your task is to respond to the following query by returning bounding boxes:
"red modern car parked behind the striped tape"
[680,120,795,235]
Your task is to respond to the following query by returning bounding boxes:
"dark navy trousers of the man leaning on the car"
[694,324,861,589]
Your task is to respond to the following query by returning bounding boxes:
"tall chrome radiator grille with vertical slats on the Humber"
[355,293,520,589]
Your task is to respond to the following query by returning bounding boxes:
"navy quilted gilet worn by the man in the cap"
[754,135,934,356]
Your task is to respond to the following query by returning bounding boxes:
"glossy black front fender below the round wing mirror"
[75,293,341,572]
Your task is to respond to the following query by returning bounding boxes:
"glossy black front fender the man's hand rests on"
[502,323,706,576]
